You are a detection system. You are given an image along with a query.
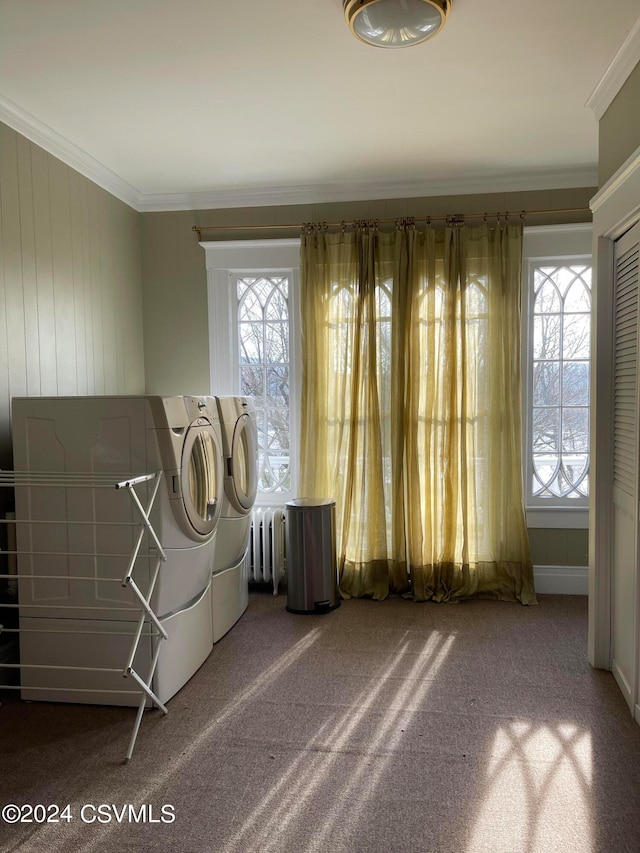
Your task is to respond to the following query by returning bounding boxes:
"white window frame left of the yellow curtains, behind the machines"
[200,238,301,506]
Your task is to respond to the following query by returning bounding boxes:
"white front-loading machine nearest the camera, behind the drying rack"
[12,396,223,705]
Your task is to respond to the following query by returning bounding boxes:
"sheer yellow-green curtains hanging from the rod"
[301,222,536,604]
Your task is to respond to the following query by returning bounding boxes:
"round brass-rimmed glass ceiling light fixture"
[343,0,452,48]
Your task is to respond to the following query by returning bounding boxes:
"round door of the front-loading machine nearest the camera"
[181,420,224,539]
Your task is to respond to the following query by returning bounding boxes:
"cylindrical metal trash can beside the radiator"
[286,498,340,613]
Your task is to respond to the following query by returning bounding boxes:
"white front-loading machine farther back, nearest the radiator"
[211,397,258,643]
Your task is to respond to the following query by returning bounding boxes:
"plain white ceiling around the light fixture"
[0,0,639,209]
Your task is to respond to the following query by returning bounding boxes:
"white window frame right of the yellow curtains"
[522,223,594,529]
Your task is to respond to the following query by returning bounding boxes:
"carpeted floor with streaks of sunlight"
[0,593,640,853]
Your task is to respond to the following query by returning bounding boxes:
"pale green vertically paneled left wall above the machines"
[0,118,145,466]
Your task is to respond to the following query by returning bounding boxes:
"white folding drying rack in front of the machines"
[0,471,168,763]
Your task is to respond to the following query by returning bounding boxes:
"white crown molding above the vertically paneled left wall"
[0,94,140,210]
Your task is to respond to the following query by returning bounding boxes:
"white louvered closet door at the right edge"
[611,223,640,711]
